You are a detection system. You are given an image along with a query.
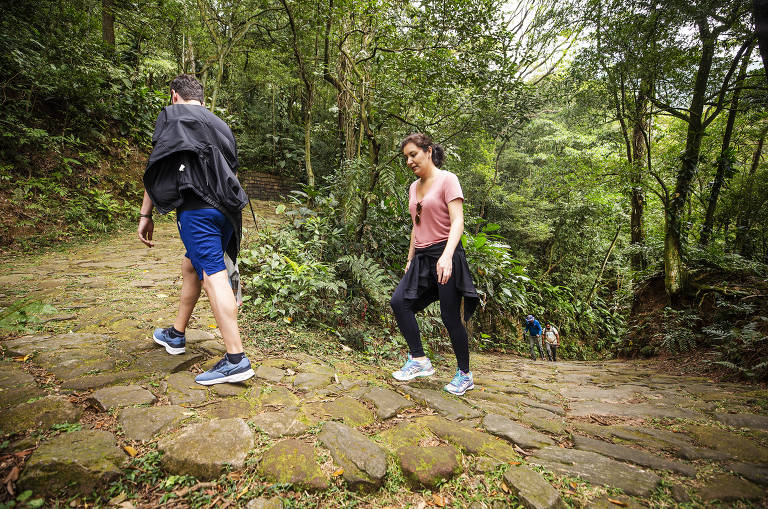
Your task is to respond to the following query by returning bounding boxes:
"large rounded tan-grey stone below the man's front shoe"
[157,419,253,479]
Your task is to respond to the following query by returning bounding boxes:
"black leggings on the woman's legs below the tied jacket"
[389,275,469,373]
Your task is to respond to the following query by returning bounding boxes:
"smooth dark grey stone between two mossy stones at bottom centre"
[317,421,387,490]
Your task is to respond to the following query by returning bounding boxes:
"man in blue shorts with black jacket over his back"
[138,74,253,385]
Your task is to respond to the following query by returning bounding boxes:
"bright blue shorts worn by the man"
[176,209,235,281]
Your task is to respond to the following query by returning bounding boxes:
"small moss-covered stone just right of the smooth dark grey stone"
[397,445,461,488]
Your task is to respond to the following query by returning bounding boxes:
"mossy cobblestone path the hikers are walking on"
[0,204,768,509]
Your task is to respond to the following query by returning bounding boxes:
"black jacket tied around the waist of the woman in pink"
[400,241,480,321]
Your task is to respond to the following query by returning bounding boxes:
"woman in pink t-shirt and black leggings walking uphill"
[390,133,480,396]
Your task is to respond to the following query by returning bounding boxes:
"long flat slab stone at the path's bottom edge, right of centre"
[528,447,661,497]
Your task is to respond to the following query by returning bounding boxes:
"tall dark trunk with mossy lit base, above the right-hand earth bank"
[664,19,717,305]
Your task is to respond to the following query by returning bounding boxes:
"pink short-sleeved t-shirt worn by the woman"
[408,170,464,248]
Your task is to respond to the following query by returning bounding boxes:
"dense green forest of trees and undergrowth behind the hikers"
[0,0,768,378]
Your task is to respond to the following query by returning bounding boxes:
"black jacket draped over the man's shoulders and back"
[144,104,248,261]
